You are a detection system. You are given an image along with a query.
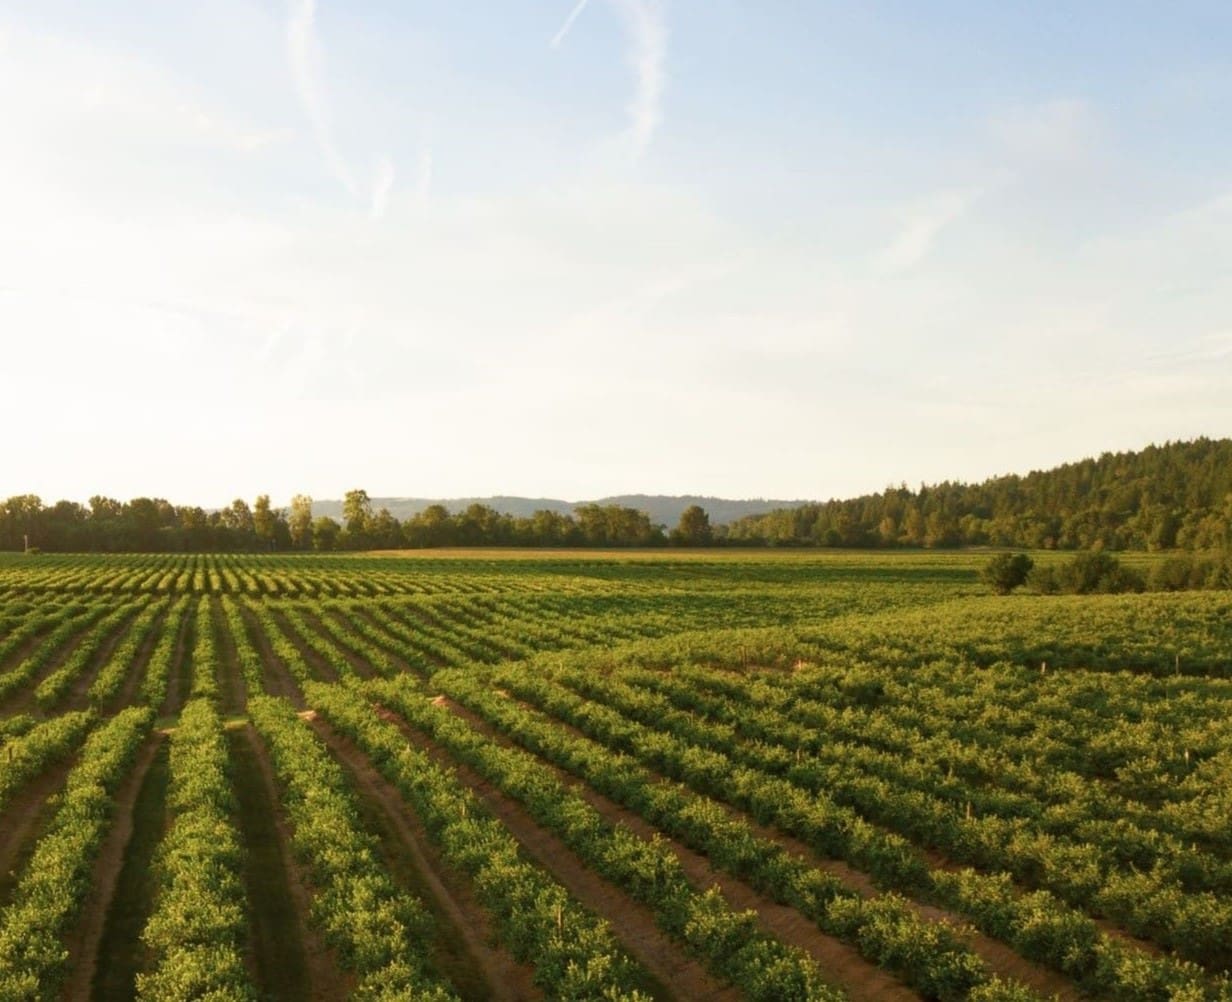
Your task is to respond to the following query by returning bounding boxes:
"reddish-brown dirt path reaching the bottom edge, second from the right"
[436,699,919,1002]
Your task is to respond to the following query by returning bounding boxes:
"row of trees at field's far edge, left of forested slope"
[0,489,711,552]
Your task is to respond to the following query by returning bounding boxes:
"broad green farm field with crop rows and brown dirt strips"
[0,550,1232,1002]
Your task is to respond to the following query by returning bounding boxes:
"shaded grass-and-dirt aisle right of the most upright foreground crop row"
[227,723,354,1002]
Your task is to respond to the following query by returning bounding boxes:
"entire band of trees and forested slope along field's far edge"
[0,438,1232,552]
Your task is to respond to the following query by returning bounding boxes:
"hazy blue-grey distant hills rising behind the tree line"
[312,494,806,529]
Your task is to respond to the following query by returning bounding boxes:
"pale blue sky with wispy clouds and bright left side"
[0,0,1232,505]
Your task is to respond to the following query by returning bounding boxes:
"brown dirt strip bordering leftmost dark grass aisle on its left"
[60,733,164,1002]
